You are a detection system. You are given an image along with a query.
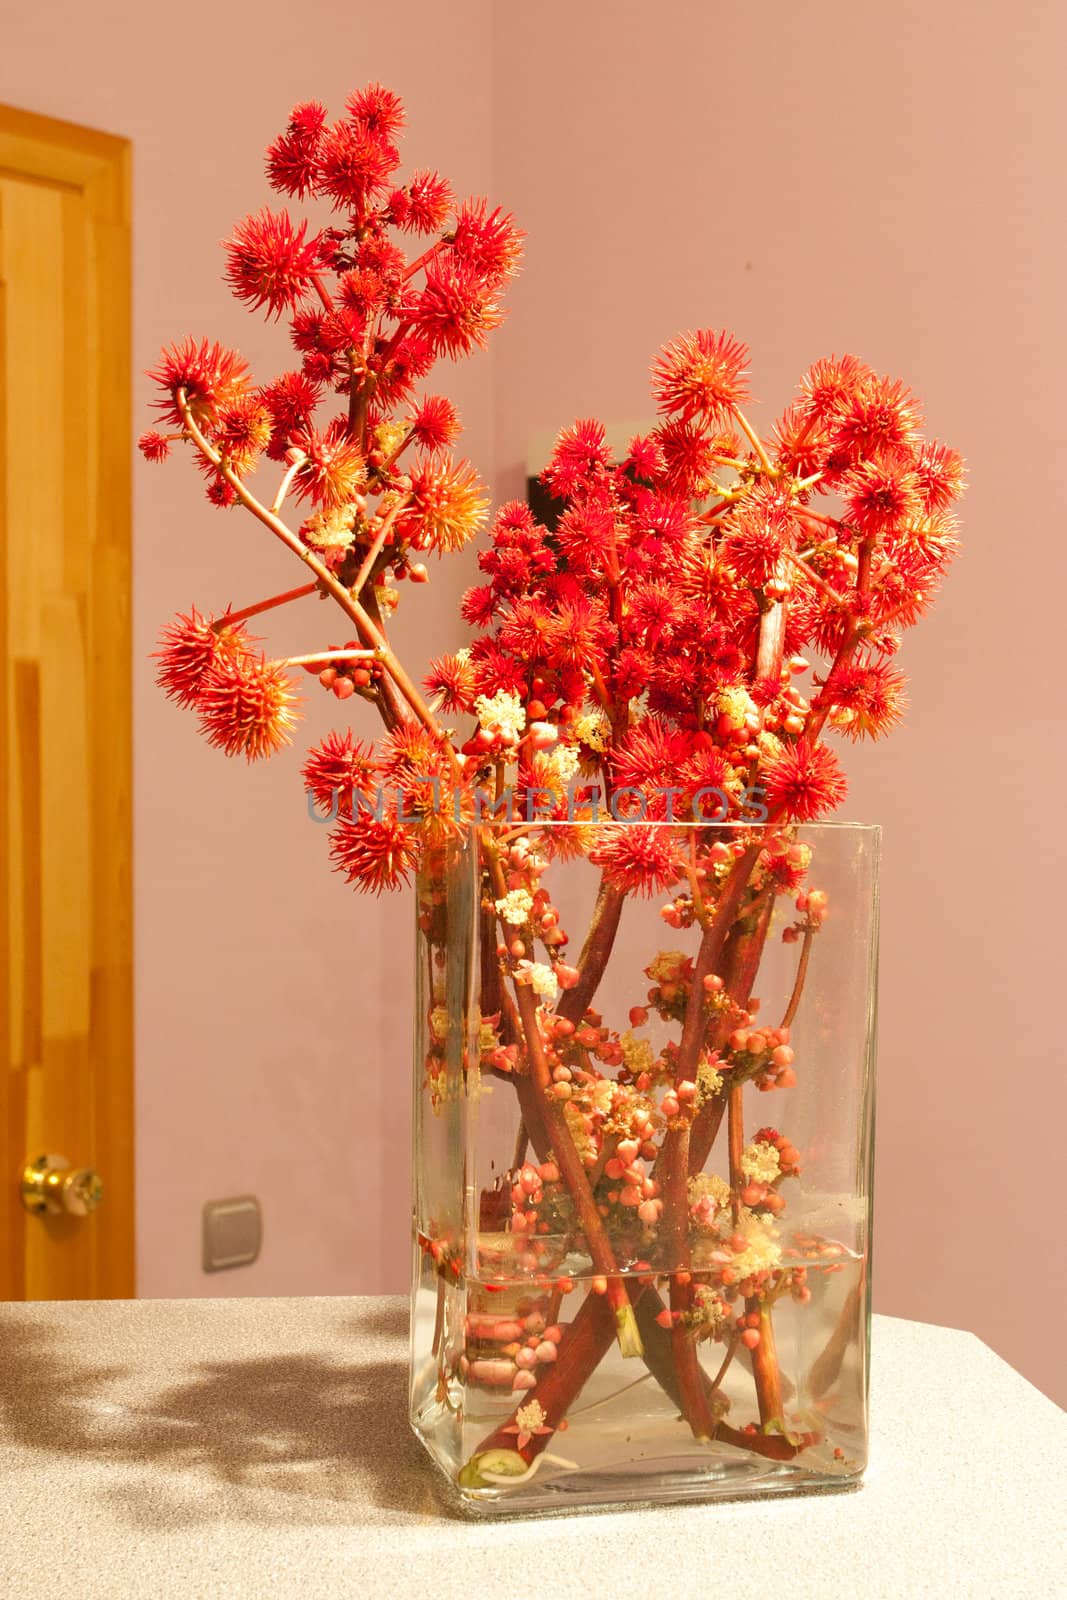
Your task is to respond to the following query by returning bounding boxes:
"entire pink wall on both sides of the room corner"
[0,0,1067,1389]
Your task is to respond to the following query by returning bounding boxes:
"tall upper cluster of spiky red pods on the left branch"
[141,85,522,579]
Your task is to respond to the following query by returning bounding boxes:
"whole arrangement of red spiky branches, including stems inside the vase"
[141,85,963,1491]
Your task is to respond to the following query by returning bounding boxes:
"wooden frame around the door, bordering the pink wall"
[0,106,134,1299]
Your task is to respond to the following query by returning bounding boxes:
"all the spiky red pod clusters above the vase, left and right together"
[141,85,963,915]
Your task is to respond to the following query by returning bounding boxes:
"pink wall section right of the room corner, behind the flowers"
[494,0,1067,1395]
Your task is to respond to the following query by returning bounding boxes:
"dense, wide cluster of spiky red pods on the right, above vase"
[447,330,963,864]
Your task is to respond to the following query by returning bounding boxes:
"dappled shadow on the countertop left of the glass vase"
[0,1307,456,1530]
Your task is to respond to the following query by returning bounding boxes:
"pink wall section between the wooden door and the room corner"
[0,0,491,1296]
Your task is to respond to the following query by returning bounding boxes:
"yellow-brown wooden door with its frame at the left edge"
[0,107,133,1299]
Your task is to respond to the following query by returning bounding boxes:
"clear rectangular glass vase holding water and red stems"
[411,819,880,1515]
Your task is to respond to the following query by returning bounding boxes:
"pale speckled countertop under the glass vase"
[0,1299,1067,1600]
